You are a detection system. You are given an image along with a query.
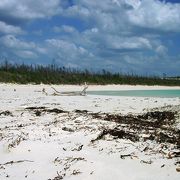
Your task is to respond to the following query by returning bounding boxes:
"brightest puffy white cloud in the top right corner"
[127,0,180,32]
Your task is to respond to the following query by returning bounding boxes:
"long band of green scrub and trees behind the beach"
[0,61,180,86]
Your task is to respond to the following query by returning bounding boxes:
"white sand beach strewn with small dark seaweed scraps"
[0,84,180,180]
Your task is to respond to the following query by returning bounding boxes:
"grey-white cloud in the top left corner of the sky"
[0,0,61,24]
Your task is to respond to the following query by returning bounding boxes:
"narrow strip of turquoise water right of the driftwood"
[87,89,180,98]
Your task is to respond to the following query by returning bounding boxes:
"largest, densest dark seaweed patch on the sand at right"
[91,111,180,148]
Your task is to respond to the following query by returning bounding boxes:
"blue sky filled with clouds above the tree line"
[0,0,180,76]
